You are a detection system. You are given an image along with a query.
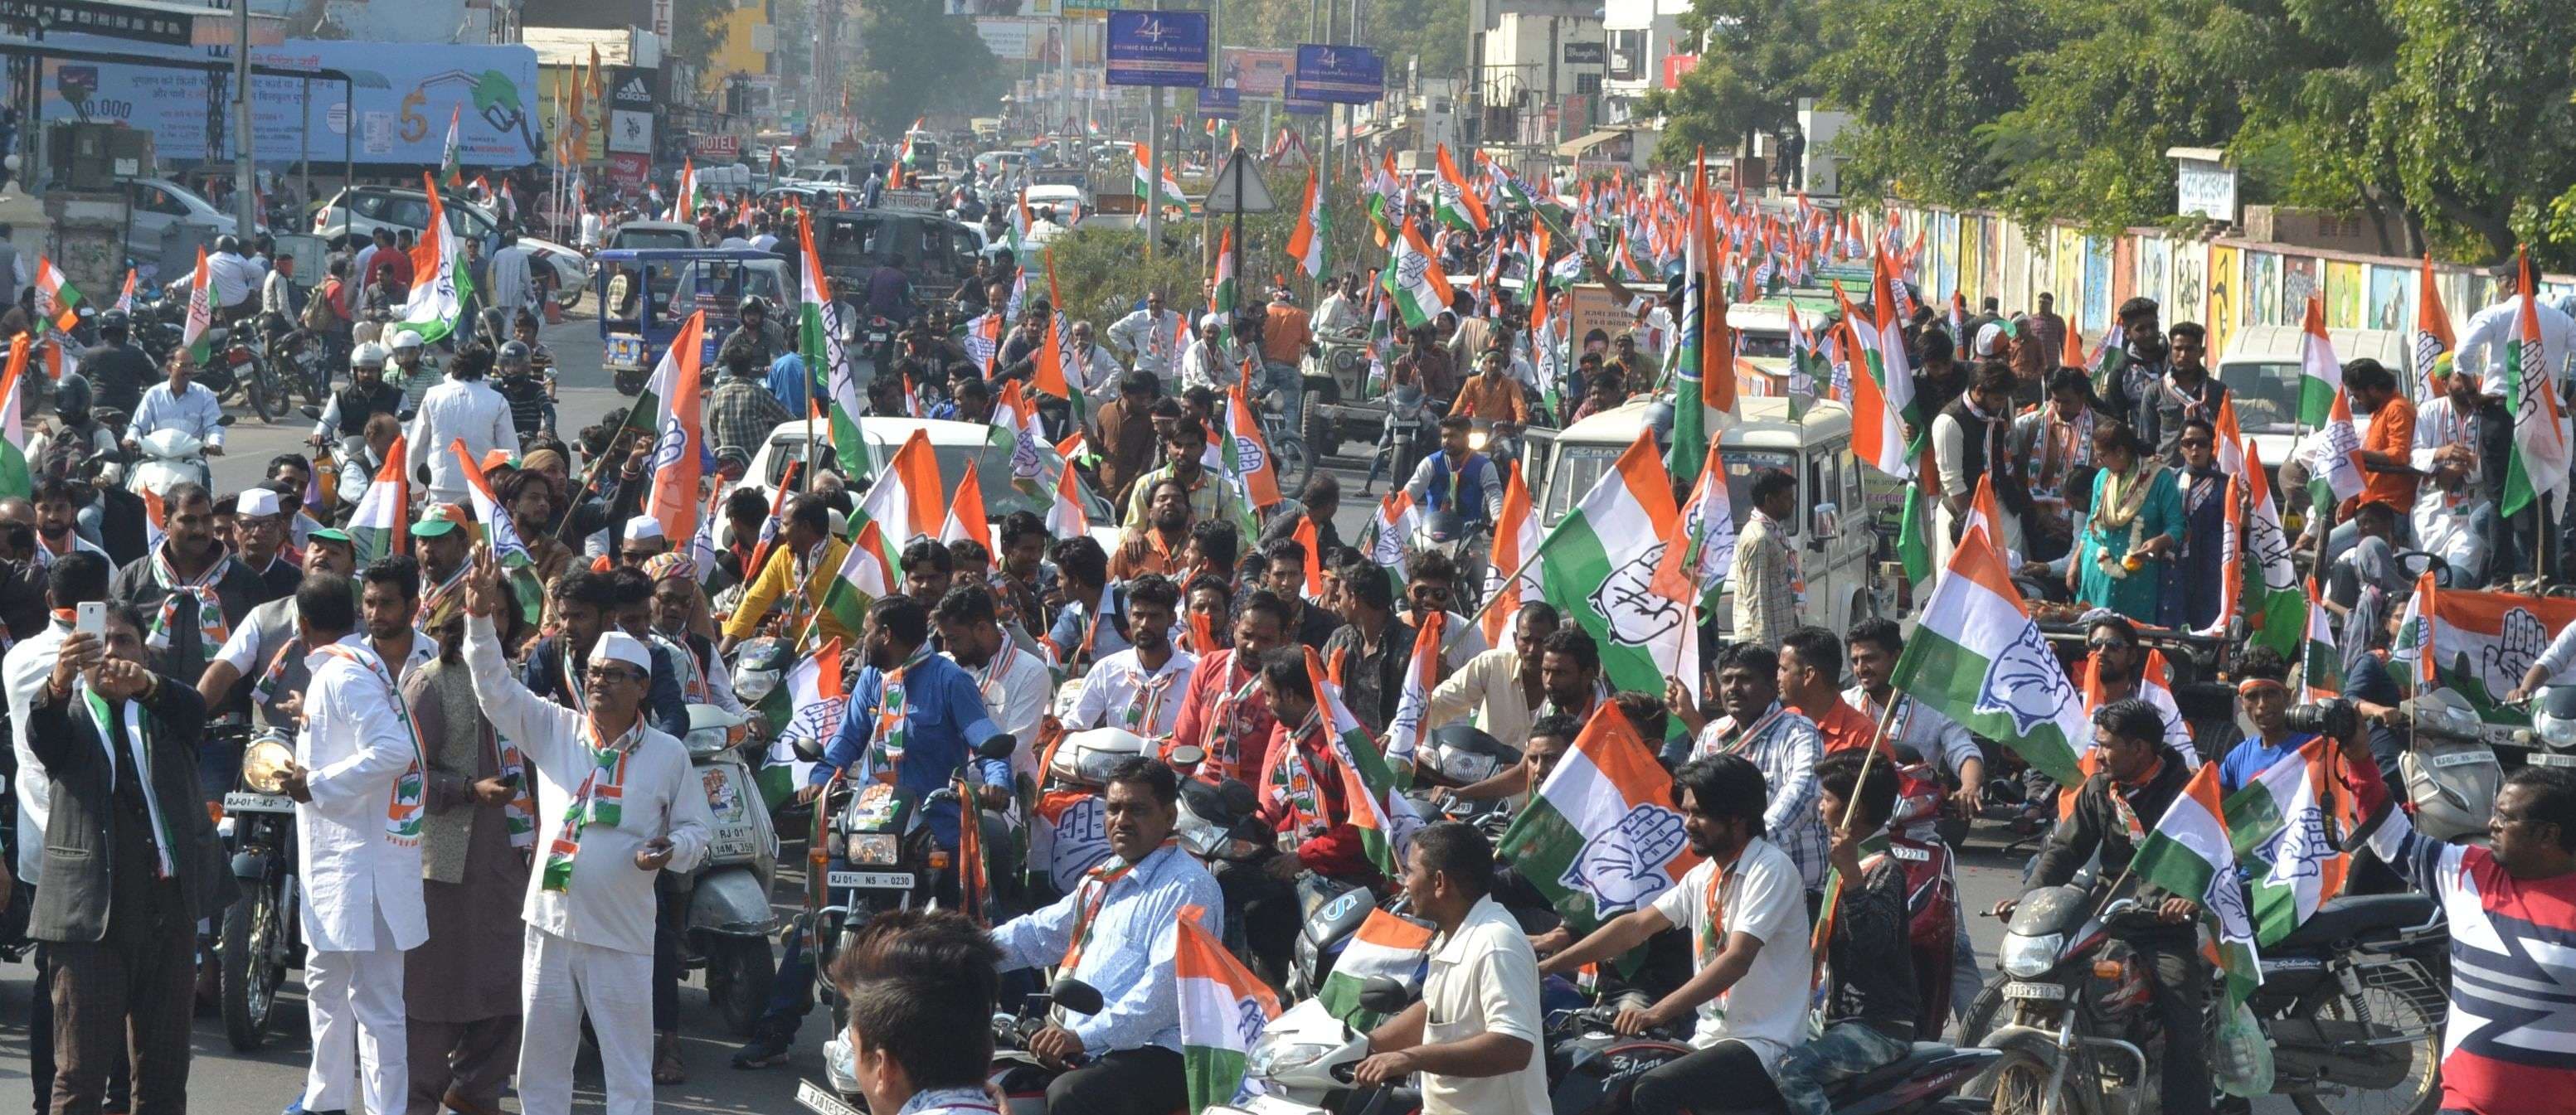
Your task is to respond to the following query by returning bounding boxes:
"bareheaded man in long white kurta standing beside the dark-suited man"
[286,574,430,1113]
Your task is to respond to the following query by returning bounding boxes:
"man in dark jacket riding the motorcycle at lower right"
[1994,698,2210,1115]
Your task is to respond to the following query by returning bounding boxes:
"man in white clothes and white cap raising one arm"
[466,549,713,1115]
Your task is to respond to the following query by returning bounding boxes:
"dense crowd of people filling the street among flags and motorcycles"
[0,134,2576,1115]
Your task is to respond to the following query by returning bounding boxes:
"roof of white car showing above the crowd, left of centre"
[745,414,1118,551]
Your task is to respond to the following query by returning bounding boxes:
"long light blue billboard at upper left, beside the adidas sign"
[36,39,543,167]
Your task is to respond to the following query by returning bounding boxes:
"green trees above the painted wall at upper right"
[1654,0,2576,268]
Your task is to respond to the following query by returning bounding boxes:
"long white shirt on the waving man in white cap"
[466,615,713,955]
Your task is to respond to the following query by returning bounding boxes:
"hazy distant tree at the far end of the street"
[848,0,1010,137]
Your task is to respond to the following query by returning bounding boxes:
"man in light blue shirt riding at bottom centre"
[992,757,1226,1115]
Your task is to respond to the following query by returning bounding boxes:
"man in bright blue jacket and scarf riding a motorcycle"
[796,595,1010,852]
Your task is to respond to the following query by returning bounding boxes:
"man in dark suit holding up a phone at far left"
[28,592,237,1115]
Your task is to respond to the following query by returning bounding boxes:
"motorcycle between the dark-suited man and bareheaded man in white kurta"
[216,729,304,1053]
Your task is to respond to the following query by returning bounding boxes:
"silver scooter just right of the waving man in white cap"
[680,705,778,1035]
